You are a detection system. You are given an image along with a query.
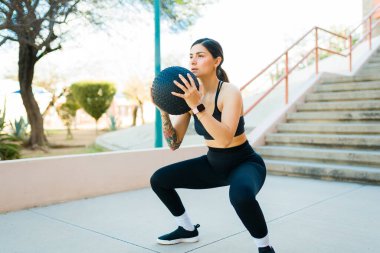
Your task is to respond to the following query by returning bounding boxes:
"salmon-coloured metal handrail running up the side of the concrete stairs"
[240,4,380,115]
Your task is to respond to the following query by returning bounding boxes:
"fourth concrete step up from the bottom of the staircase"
[277,123,380,135]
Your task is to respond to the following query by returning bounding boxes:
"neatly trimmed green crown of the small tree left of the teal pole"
[71,82,116,129]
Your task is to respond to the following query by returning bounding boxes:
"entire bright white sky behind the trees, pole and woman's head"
[0,0,362,90]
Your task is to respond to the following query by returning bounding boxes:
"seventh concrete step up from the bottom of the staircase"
[305,90,380,102]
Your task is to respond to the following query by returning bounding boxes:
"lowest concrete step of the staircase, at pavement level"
[265,159,380,184]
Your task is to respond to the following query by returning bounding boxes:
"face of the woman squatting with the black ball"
[189,44,220,78]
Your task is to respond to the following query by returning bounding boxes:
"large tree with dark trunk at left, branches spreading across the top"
[0,0,214,148]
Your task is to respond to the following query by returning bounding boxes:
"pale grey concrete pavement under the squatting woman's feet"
[0,175,380,253]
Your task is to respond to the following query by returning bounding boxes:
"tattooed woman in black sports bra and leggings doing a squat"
[151,38,274,253]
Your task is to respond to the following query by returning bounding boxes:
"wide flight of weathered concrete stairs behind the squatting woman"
[255,49,380,184]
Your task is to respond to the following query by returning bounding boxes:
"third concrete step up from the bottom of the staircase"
[265,133,380,150]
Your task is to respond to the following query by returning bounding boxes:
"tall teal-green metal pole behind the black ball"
[154,0,162,148]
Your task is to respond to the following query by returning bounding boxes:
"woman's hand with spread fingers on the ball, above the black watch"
[172,74,203,109]
